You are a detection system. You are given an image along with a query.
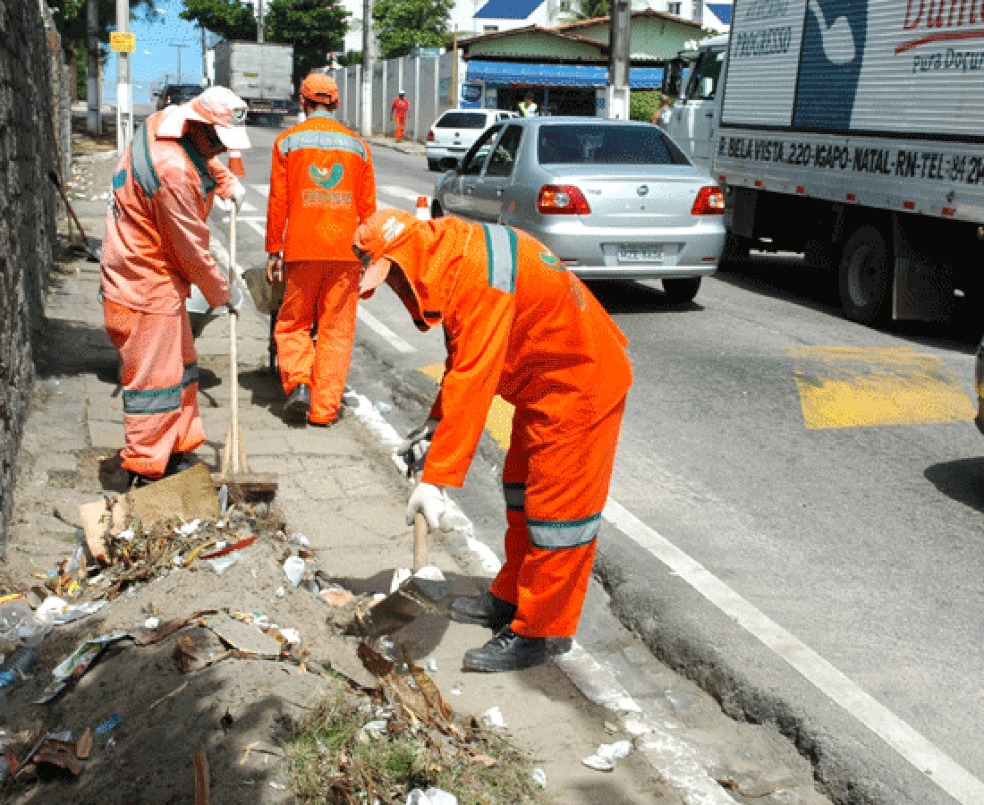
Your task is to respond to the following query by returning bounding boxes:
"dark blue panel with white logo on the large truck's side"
[793,0,868,131]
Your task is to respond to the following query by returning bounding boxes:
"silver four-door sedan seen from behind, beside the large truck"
[431,117,725,302]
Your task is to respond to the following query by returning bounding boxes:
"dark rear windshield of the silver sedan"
[537,125,690,165]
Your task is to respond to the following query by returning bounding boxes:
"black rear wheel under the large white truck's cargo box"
[840,226,892,325]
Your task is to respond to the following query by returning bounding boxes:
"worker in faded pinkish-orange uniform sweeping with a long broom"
[101,87,250,486]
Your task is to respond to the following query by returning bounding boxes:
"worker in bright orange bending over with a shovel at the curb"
[354,210,632,671]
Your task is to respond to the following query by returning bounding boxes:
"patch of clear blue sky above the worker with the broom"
[103,0,232,104]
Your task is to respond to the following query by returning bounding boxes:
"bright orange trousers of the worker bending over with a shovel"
[491,400,625,637]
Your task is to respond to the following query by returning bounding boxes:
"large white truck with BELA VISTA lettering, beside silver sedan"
[664,0,984,325]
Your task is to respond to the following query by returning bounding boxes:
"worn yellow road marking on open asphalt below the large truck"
[788,347,976,429]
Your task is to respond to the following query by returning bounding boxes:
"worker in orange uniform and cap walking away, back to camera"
[266,72,376,426]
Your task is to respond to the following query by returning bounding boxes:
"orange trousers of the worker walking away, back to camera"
[273,260,360,424]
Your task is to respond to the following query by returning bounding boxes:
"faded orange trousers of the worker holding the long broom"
[103,299,205,478]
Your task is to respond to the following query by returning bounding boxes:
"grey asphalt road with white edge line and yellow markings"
[223,122,984,805]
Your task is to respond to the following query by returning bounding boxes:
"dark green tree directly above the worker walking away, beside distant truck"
[265,0,349,86]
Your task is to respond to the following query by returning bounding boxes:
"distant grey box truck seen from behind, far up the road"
[214,40,294,126]
